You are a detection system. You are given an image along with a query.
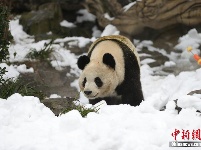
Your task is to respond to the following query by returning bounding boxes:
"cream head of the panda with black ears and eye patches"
[77,53,118,99]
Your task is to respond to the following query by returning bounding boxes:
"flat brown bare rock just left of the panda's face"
[21,61,78,97]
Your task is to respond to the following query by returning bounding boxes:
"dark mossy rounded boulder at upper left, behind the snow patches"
[20,3,63,36]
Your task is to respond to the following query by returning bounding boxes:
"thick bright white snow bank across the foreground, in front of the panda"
[0,94,201,150]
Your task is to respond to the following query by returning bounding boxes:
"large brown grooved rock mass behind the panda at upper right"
[84,0,201,51]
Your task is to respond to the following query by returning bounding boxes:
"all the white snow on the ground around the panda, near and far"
[0,15,201,150]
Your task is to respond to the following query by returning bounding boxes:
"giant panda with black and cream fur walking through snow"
[77,35,144,106]
